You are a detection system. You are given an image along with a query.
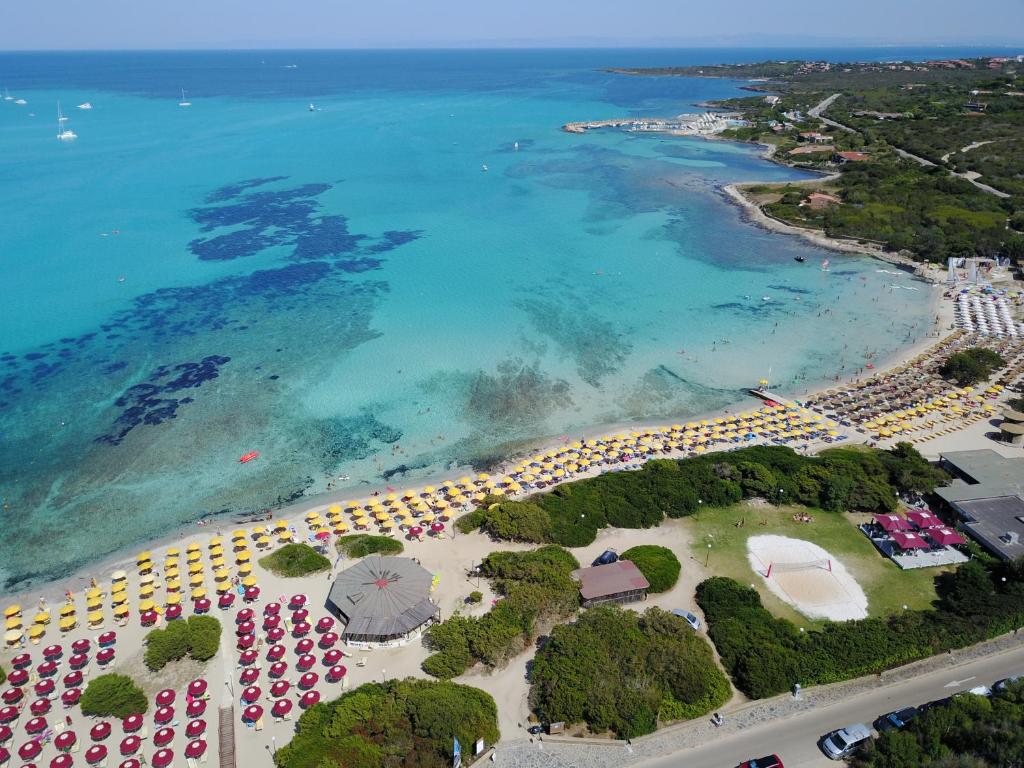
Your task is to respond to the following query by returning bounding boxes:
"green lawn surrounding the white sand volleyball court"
[683,504,942,628]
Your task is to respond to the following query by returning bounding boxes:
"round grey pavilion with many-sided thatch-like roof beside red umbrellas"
[328,555,440,643]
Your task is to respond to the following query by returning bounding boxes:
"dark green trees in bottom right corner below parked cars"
[853,682,1024,768]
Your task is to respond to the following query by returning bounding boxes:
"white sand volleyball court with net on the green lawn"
[746,536,867,622]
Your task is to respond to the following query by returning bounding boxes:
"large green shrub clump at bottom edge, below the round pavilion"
[273,678,499,768]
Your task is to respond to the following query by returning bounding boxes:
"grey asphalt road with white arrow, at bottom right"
[640,645,1024,768]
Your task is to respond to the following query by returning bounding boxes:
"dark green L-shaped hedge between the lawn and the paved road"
[697,561,1024,698]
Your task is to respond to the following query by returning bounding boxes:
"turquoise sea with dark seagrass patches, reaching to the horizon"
[0,51,950,591]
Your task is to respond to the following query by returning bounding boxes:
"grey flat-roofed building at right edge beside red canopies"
[935,449,1024,560]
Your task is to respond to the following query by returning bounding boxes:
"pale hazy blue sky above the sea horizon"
[6,0,1024,50]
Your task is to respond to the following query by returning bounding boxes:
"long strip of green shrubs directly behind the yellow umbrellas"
[457,443,946,547]
